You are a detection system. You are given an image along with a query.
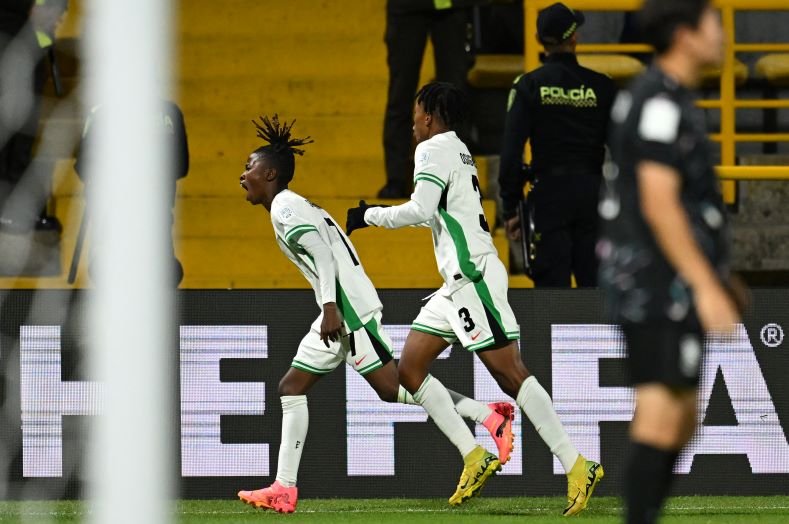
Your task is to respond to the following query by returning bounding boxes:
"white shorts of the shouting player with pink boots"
[290,311,392,375]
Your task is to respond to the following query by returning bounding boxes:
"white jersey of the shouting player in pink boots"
[271,189,383,332]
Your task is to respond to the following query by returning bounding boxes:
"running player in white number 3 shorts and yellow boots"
[347,82,603,515]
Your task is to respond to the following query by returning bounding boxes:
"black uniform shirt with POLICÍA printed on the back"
[499,53,616,218]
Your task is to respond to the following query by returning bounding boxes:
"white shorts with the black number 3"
[411,257,520,351]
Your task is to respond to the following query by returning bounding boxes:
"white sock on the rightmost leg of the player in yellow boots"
[515,376,578,473]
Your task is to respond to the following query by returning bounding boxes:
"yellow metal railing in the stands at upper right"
[524,0,789,195]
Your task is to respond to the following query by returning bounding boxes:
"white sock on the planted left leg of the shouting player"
[277,395,310,488]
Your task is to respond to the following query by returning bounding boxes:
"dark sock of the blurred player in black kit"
[624,442,678,524]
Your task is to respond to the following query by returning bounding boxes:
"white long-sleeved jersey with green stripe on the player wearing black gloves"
[365,131,498,292]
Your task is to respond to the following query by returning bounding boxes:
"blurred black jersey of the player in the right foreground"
[598,67,729,323]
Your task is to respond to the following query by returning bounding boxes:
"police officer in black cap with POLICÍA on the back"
[499,3,616,287]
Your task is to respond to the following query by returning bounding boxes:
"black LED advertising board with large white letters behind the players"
[0,289,789,498]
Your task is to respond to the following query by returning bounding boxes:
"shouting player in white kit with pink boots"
[238,115,514,513]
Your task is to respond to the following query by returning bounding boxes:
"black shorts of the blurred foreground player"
[622,320,704,388]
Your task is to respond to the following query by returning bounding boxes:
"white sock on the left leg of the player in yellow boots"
[414,375,477,458]
